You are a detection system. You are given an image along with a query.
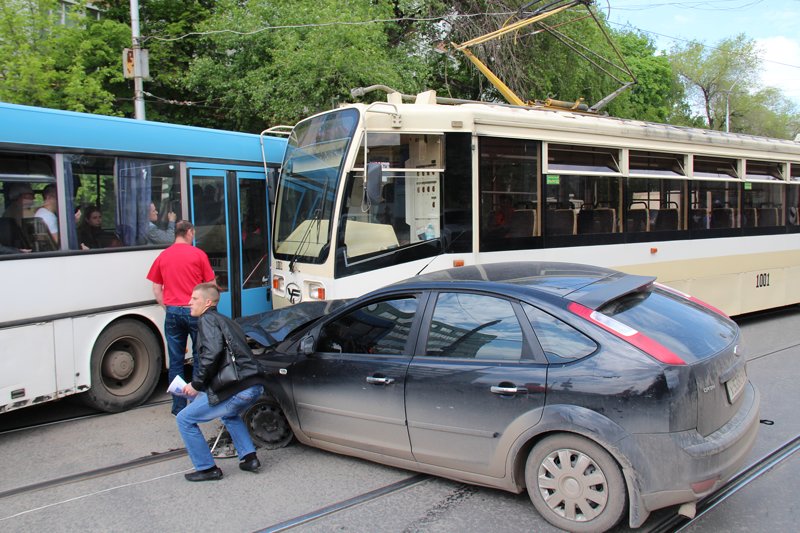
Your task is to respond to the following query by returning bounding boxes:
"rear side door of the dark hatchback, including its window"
[406,292,547,477]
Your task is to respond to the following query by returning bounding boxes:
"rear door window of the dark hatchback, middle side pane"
[425,292,524,361]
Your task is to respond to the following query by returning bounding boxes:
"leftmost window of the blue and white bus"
[0,153,59,255]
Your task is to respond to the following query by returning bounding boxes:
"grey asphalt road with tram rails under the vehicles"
[0,307,800,533]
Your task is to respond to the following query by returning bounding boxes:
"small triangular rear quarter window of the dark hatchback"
[522,304,597,363]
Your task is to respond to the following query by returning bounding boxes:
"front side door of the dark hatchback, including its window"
[290,294,420,459]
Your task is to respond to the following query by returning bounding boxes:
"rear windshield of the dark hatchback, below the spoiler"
[598,288,738,363]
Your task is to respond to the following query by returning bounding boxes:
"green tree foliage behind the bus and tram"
[0,0,800,137]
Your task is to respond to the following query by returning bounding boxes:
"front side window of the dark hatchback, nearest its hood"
[317,296,417,355]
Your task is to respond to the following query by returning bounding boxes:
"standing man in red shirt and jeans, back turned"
[147,220,214,415]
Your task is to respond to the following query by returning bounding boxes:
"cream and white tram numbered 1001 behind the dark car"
[271,90,800,315]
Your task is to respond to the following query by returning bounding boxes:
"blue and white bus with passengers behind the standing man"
[0,103,286,413]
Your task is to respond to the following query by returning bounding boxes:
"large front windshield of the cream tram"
[274,109,358,263]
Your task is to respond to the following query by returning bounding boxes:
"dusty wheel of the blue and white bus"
[81,320,163,413]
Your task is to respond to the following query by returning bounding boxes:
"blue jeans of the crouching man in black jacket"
[178,385,264,470]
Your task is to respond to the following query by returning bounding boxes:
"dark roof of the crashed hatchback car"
[391,261,656,309]
